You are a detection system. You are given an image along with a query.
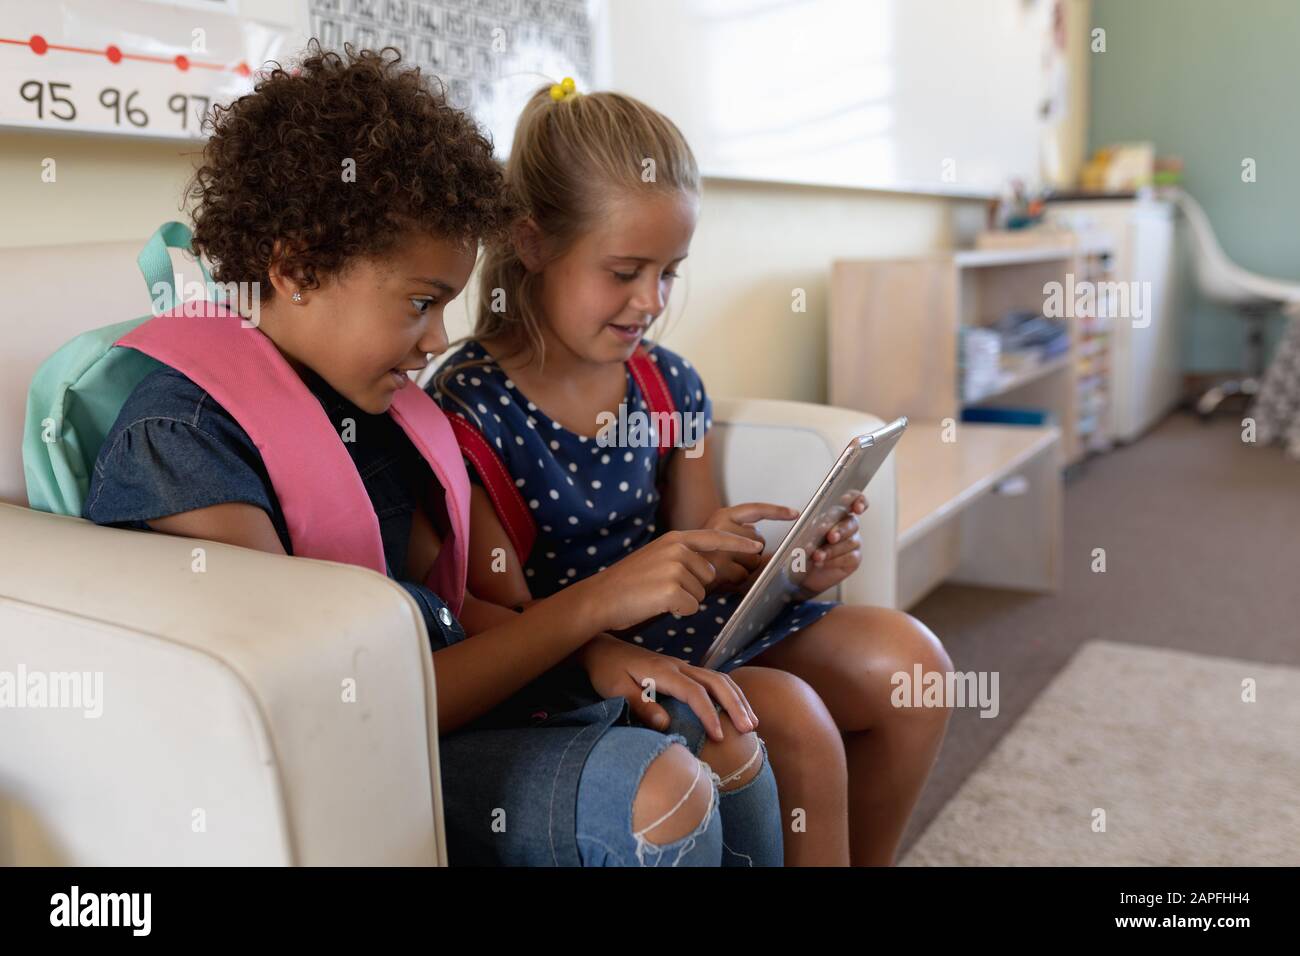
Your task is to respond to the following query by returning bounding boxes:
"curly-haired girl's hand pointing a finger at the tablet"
[572,529,763,632]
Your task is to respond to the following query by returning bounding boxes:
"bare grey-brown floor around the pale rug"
[900,412,1300,857]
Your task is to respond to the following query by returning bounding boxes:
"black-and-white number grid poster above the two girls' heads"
[303,0,597,151]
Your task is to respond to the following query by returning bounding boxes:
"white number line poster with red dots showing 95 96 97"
[0,0,298,139]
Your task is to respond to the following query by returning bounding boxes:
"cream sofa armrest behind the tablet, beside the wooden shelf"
[714,398,898,607]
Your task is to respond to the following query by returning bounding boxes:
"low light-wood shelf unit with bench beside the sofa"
[828,245,1076,609]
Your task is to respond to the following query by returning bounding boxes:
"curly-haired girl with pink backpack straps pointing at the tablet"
[85,47,781,865]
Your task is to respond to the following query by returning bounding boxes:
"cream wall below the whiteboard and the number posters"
[0,130,970,402]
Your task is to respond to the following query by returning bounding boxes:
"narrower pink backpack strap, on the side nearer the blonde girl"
[387,385,470,614]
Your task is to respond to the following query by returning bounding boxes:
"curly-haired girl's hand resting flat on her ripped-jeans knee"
[579,635,758,740]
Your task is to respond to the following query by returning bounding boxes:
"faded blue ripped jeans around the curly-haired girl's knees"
[576,696,784,866]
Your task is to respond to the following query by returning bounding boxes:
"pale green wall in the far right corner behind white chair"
[1088,0,1300,372]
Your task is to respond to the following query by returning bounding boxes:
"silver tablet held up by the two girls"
[701,418,907,670]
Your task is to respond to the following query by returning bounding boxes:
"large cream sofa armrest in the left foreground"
[0,505,446,866]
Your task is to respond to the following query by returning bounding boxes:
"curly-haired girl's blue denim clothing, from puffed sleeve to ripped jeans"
[83,365,780,866]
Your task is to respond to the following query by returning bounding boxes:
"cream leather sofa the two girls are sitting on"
[0,243,896,865]
